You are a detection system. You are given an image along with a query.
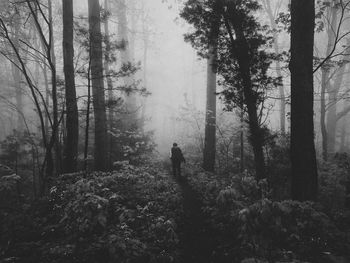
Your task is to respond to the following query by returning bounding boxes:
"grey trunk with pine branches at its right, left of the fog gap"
[88,0,107,171]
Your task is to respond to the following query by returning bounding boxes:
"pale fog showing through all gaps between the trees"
[0,0,349,161]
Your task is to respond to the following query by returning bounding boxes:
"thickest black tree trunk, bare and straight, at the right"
[289,0,318,201]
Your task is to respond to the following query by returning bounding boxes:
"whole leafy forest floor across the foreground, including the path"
[0,162,350,263]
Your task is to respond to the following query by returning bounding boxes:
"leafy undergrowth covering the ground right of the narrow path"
[183,167,350,262]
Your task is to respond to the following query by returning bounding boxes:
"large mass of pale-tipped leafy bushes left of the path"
[4,165,182,263]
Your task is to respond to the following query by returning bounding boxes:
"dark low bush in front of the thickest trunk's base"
[236,199,349,262]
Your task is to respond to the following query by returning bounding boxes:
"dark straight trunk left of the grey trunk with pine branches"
[62,0,79,173]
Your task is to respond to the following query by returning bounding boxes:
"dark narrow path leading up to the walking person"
[175,177,215,263]
